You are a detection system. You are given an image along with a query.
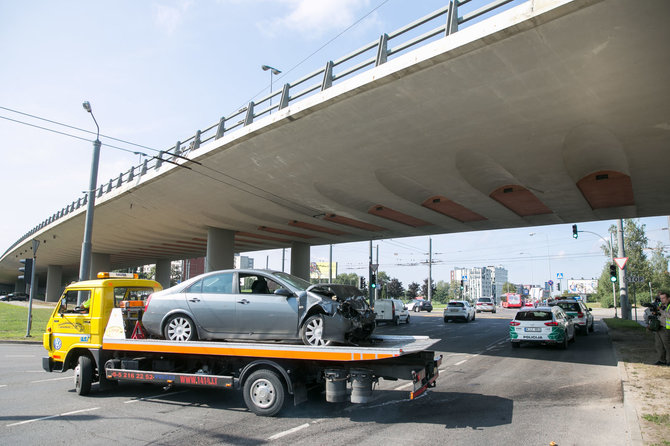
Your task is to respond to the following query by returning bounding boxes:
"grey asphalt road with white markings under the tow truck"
[0,310,627,446]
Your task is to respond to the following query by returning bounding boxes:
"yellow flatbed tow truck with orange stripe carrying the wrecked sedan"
[42,273,442,416]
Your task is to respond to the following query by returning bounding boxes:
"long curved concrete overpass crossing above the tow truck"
[0,0,670,298]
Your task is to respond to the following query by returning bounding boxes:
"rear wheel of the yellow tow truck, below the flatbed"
[244,370,286,417]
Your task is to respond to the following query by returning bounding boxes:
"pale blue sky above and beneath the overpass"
[0,0,670,286]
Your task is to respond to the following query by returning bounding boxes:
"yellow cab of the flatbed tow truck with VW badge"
[42,273,162,372]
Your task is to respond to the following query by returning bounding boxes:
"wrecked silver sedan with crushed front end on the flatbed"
[142,269,375,346]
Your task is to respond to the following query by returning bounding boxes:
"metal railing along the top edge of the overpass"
[3,0,519,255]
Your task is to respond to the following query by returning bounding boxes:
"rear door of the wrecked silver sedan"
[184,272,237,333]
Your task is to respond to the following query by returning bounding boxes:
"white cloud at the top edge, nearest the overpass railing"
[260,0,378,37]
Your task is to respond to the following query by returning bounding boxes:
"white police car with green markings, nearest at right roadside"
[509,306,575,349]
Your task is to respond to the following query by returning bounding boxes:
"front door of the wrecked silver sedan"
[235,273,298,339]
